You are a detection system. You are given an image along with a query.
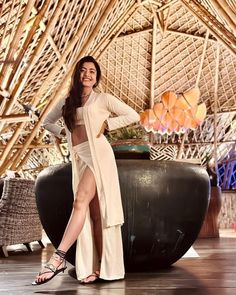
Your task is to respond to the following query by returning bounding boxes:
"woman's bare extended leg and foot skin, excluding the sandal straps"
[36,167,96,282]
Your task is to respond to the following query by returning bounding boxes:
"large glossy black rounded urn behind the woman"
[36,159,210,271]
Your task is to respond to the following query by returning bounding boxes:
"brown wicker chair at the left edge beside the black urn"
[0,178,44,257]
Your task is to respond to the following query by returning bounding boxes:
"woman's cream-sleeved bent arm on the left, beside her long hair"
[42,99,65,137]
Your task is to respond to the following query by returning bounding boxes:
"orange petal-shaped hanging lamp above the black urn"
[140,88,207,135]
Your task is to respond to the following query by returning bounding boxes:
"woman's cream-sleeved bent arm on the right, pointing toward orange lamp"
[106,94,140,131]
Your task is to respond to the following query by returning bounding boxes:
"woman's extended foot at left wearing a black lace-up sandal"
[32,250,67,285]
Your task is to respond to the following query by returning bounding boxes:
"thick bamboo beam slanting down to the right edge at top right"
[181,0,236,56]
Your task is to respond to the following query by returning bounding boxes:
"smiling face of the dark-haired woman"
[80,62,97,88]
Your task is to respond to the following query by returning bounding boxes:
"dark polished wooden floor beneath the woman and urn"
[0,231,236,295]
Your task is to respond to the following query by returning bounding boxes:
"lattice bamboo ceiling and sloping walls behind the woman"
[0,0,236,183]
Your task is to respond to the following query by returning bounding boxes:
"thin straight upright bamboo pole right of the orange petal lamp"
[214,44,220,175]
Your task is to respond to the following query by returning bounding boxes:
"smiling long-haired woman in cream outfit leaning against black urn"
[33,56,139,285]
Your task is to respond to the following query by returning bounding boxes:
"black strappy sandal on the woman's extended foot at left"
[32,250,67,286]
